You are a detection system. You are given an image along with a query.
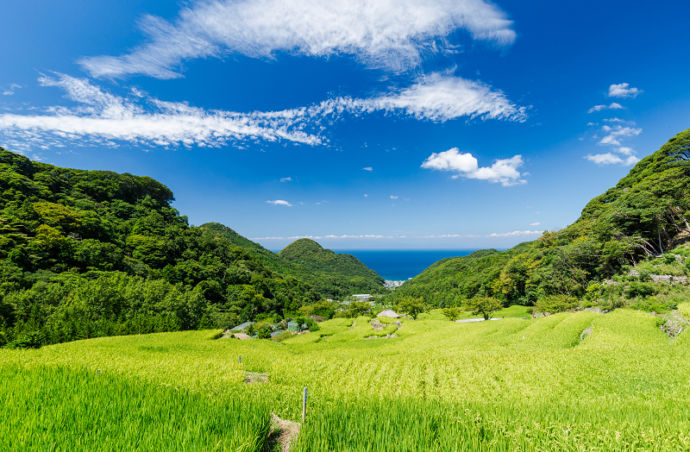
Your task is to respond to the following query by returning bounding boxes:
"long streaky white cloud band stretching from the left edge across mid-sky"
[0,73,525,147]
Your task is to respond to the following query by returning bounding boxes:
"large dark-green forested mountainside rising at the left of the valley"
[0,149,378,345]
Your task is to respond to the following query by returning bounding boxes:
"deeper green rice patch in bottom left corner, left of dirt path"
[0,364,270,451]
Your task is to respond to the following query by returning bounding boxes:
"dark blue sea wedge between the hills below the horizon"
[334,250,474,281]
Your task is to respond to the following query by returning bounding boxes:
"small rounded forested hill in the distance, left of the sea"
[278,239,383,296]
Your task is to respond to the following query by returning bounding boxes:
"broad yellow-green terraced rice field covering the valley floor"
[0,305,690,450]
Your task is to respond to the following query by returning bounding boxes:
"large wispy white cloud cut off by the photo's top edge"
[80,0,515,79]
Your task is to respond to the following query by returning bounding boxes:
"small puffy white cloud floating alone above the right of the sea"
[422,148,527,187]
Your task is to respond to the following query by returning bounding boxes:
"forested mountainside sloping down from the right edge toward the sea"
[394,130,690,306]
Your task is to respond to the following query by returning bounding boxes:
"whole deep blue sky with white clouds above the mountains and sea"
[0,0,690,249]
